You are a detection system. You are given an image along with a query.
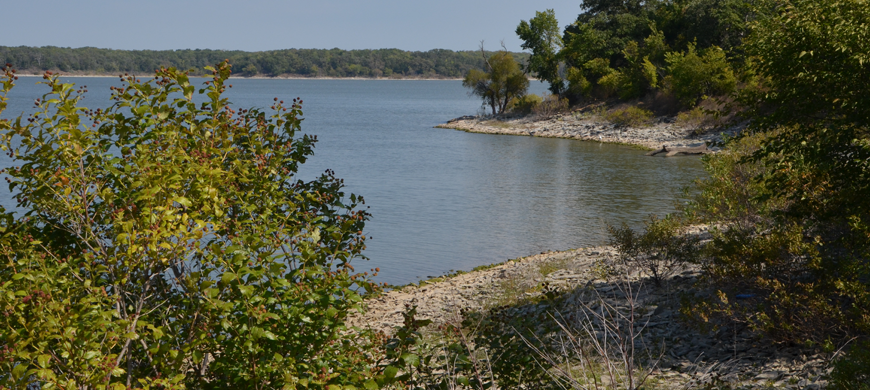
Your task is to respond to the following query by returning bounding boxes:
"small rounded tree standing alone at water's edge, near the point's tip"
[462,45,529,115]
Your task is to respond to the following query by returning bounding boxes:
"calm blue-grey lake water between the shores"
[0,77,704,284]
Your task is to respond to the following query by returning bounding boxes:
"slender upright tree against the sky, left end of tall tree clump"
[516,9,565,95]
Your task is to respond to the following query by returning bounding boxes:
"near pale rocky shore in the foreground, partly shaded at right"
[351,241,831,389]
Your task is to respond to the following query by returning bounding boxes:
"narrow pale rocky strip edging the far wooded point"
[435,112,742,150]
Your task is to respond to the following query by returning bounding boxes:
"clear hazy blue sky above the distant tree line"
[0,0,580,51]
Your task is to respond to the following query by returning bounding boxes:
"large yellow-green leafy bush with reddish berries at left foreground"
[0,63,376,389]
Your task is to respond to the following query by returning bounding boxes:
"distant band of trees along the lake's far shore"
[0,46,528,78]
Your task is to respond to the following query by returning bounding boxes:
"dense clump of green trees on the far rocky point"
[516,0,755,106]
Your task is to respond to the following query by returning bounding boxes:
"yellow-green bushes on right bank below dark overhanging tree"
[686,130,870,342]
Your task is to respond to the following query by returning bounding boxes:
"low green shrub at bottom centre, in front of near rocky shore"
[376,306,562,389]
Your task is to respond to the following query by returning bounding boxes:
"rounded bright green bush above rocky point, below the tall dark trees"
[664,44,737,106]
